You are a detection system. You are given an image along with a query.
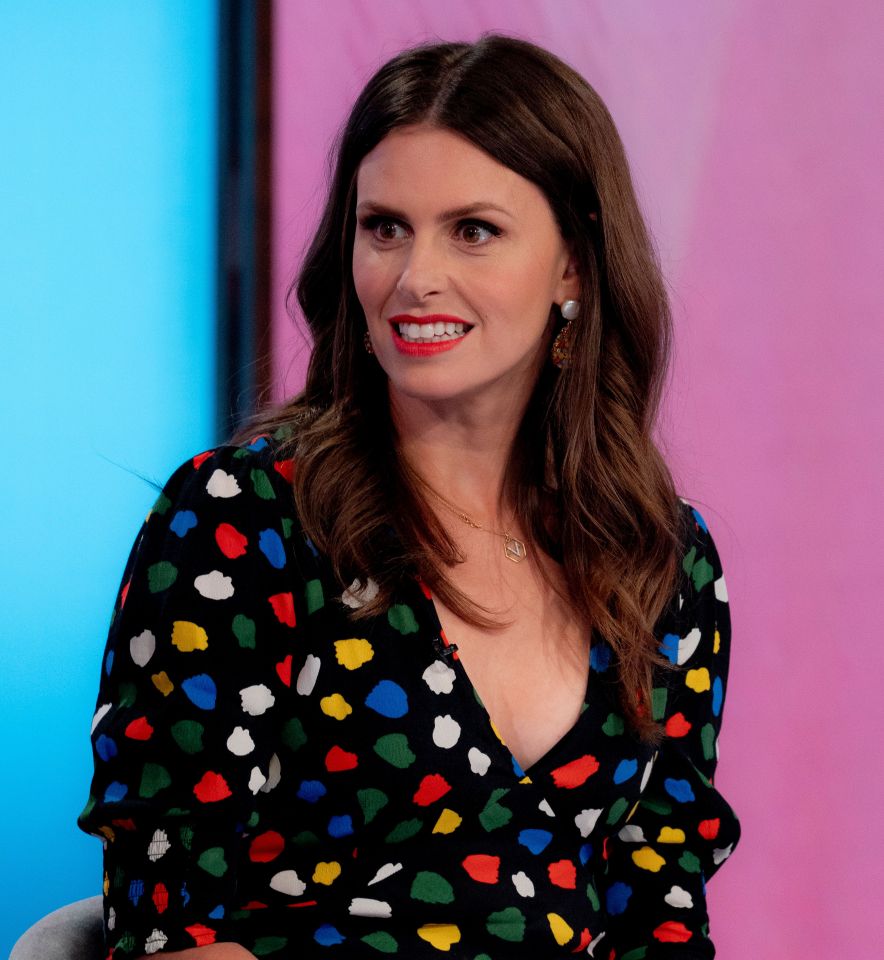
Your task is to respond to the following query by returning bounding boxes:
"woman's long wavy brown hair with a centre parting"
[240,34,681,740]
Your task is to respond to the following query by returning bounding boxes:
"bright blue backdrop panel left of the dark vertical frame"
[0,0,217,957]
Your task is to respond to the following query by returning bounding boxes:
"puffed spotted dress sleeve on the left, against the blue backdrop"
[79,441,299,958]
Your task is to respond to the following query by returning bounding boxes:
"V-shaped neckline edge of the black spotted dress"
[415,578,601,783]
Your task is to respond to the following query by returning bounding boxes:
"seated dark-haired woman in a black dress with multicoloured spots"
[81,36,739,960]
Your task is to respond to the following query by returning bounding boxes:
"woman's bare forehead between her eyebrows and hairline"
[356,125,547,212]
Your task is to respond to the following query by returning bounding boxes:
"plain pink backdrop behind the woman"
[274,0,884,960]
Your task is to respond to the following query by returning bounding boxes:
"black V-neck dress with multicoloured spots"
[79,437,739,960]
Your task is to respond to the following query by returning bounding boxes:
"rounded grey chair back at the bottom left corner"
[9,897,105,960]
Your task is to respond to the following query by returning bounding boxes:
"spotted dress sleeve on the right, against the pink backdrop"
[604,507,740,960]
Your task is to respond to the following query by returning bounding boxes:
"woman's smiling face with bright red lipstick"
[353,125,578,403]
